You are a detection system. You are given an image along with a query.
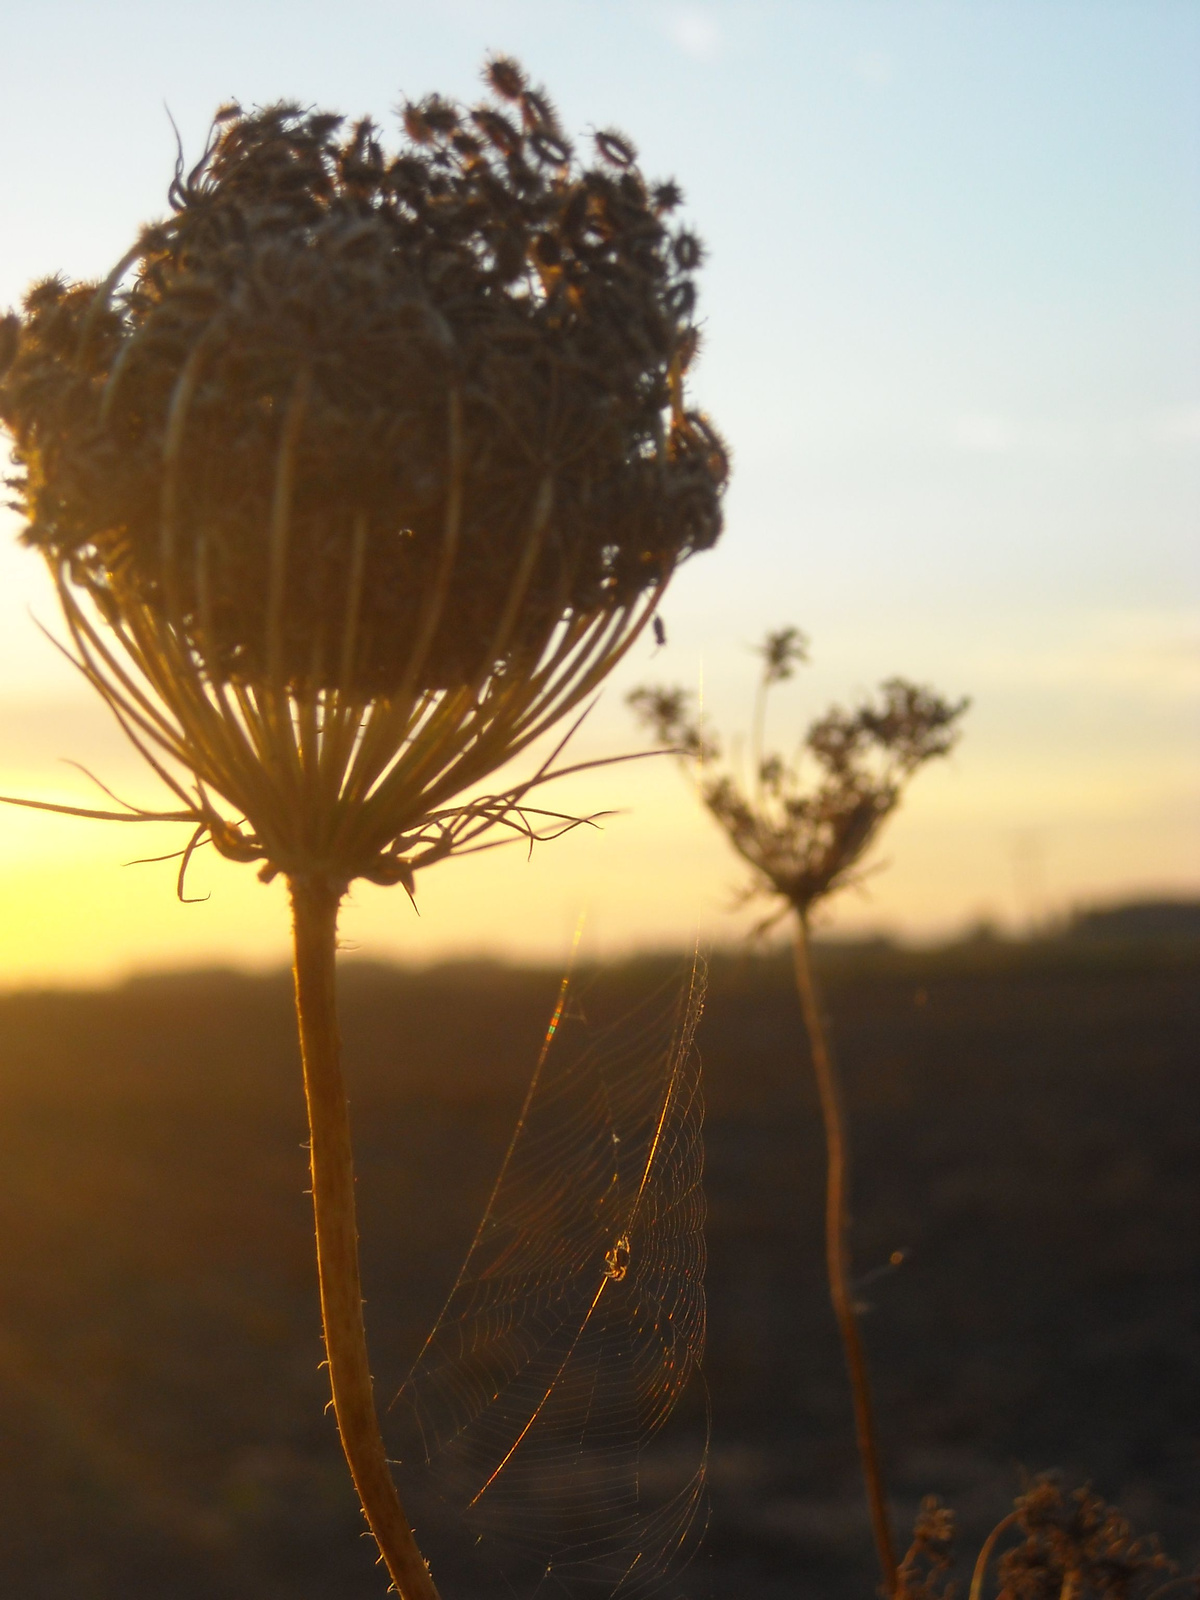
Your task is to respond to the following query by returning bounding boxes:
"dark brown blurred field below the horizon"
[0,941,1200,1600]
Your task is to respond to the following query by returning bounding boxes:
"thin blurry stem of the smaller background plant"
[795,910,898,1595]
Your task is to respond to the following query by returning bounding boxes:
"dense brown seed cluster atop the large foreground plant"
[0,58,726,696]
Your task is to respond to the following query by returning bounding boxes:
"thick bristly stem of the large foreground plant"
[290,875,438,1600]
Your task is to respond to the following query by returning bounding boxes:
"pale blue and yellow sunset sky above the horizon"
[0,0,1200,987]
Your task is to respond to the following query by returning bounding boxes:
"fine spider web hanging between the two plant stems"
[395,957,707,1600]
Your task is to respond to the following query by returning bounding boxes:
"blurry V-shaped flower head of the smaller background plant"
[630,627,968,925]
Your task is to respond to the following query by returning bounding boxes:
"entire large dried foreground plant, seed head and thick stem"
[0,59,726,1600]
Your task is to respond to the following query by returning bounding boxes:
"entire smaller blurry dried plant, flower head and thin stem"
[630,627,966,1595]
